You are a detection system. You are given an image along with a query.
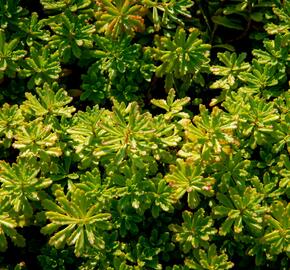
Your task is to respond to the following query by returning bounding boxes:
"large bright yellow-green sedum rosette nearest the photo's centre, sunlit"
[94,100,155,164]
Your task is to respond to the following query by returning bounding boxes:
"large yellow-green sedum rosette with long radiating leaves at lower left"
[42,187,111,256]
